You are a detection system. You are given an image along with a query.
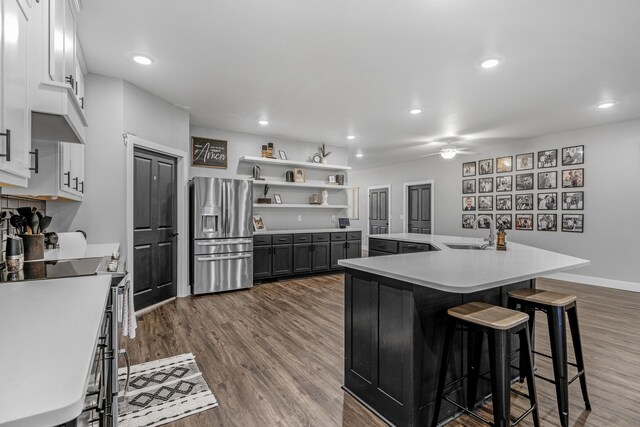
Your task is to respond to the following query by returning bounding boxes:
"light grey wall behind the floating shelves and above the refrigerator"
[188,127,348,230]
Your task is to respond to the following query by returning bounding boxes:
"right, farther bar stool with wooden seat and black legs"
[507,289,591,427]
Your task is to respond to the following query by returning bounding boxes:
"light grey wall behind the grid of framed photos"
[350,120,640,290]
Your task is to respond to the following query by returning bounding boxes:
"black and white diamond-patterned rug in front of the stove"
[118,353,218,427]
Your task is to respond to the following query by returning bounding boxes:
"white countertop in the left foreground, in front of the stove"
[0,275,111,426]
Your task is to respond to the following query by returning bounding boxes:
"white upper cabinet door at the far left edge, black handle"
[0,0,31,186]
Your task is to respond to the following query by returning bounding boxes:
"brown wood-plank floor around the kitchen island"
[123,275,640,427]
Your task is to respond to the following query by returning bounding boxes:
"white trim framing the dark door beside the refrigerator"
[123,133,190,297]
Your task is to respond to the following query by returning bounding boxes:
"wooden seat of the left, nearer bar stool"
[447,302,529,330]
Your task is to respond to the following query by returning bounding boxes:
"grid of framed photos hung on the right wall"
[462,145,585,233]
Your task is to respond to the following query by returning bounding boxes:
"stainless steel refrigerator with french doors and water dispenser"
[190,177,253,294]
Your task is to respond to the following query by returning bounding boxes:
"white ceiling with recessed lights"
[78,0,640,167]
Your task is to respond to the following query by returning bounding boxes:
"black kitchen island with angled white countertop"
[340,233,589,426]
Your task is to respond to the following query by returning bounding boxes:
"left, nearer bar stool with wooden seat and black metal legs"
[432,302,540,427]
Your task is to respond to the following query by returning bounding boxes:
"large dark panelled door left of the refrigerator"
[132,148,177,310]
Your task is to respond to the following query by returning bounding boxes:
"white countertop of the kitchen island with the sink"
[338,233,590,293]
